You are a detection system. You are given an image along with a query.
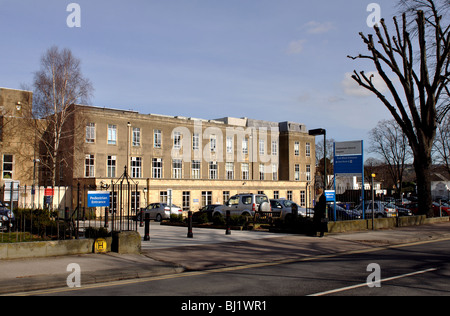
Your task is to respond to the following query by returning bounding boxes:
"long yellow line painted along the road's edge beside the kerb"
[8,238,450,296]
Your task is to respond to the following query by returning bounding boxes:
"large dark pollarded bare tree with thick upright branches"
[349,0,450,216]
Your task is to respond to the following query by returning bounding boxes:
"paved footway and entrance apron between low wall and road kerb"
[0,222,450,295]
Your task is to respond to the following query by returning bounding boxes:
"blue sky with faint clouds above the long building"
[0,0,397,148]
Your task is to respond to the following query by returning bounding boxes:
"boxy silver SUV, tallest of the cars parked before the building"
[213,193,271,217]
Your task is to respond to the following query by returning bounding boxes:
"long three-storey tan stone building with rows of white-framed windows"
[0,87,315,211]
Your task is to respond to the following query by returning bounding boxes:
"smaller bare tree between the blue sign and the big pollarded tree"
[370,120,412,194]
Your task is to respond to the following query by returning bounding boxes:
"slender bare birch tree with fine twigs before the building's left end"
[33,47,93,186]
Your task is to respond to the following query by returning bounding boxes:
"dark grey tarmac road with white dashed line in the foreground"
[29,240,450,300]
